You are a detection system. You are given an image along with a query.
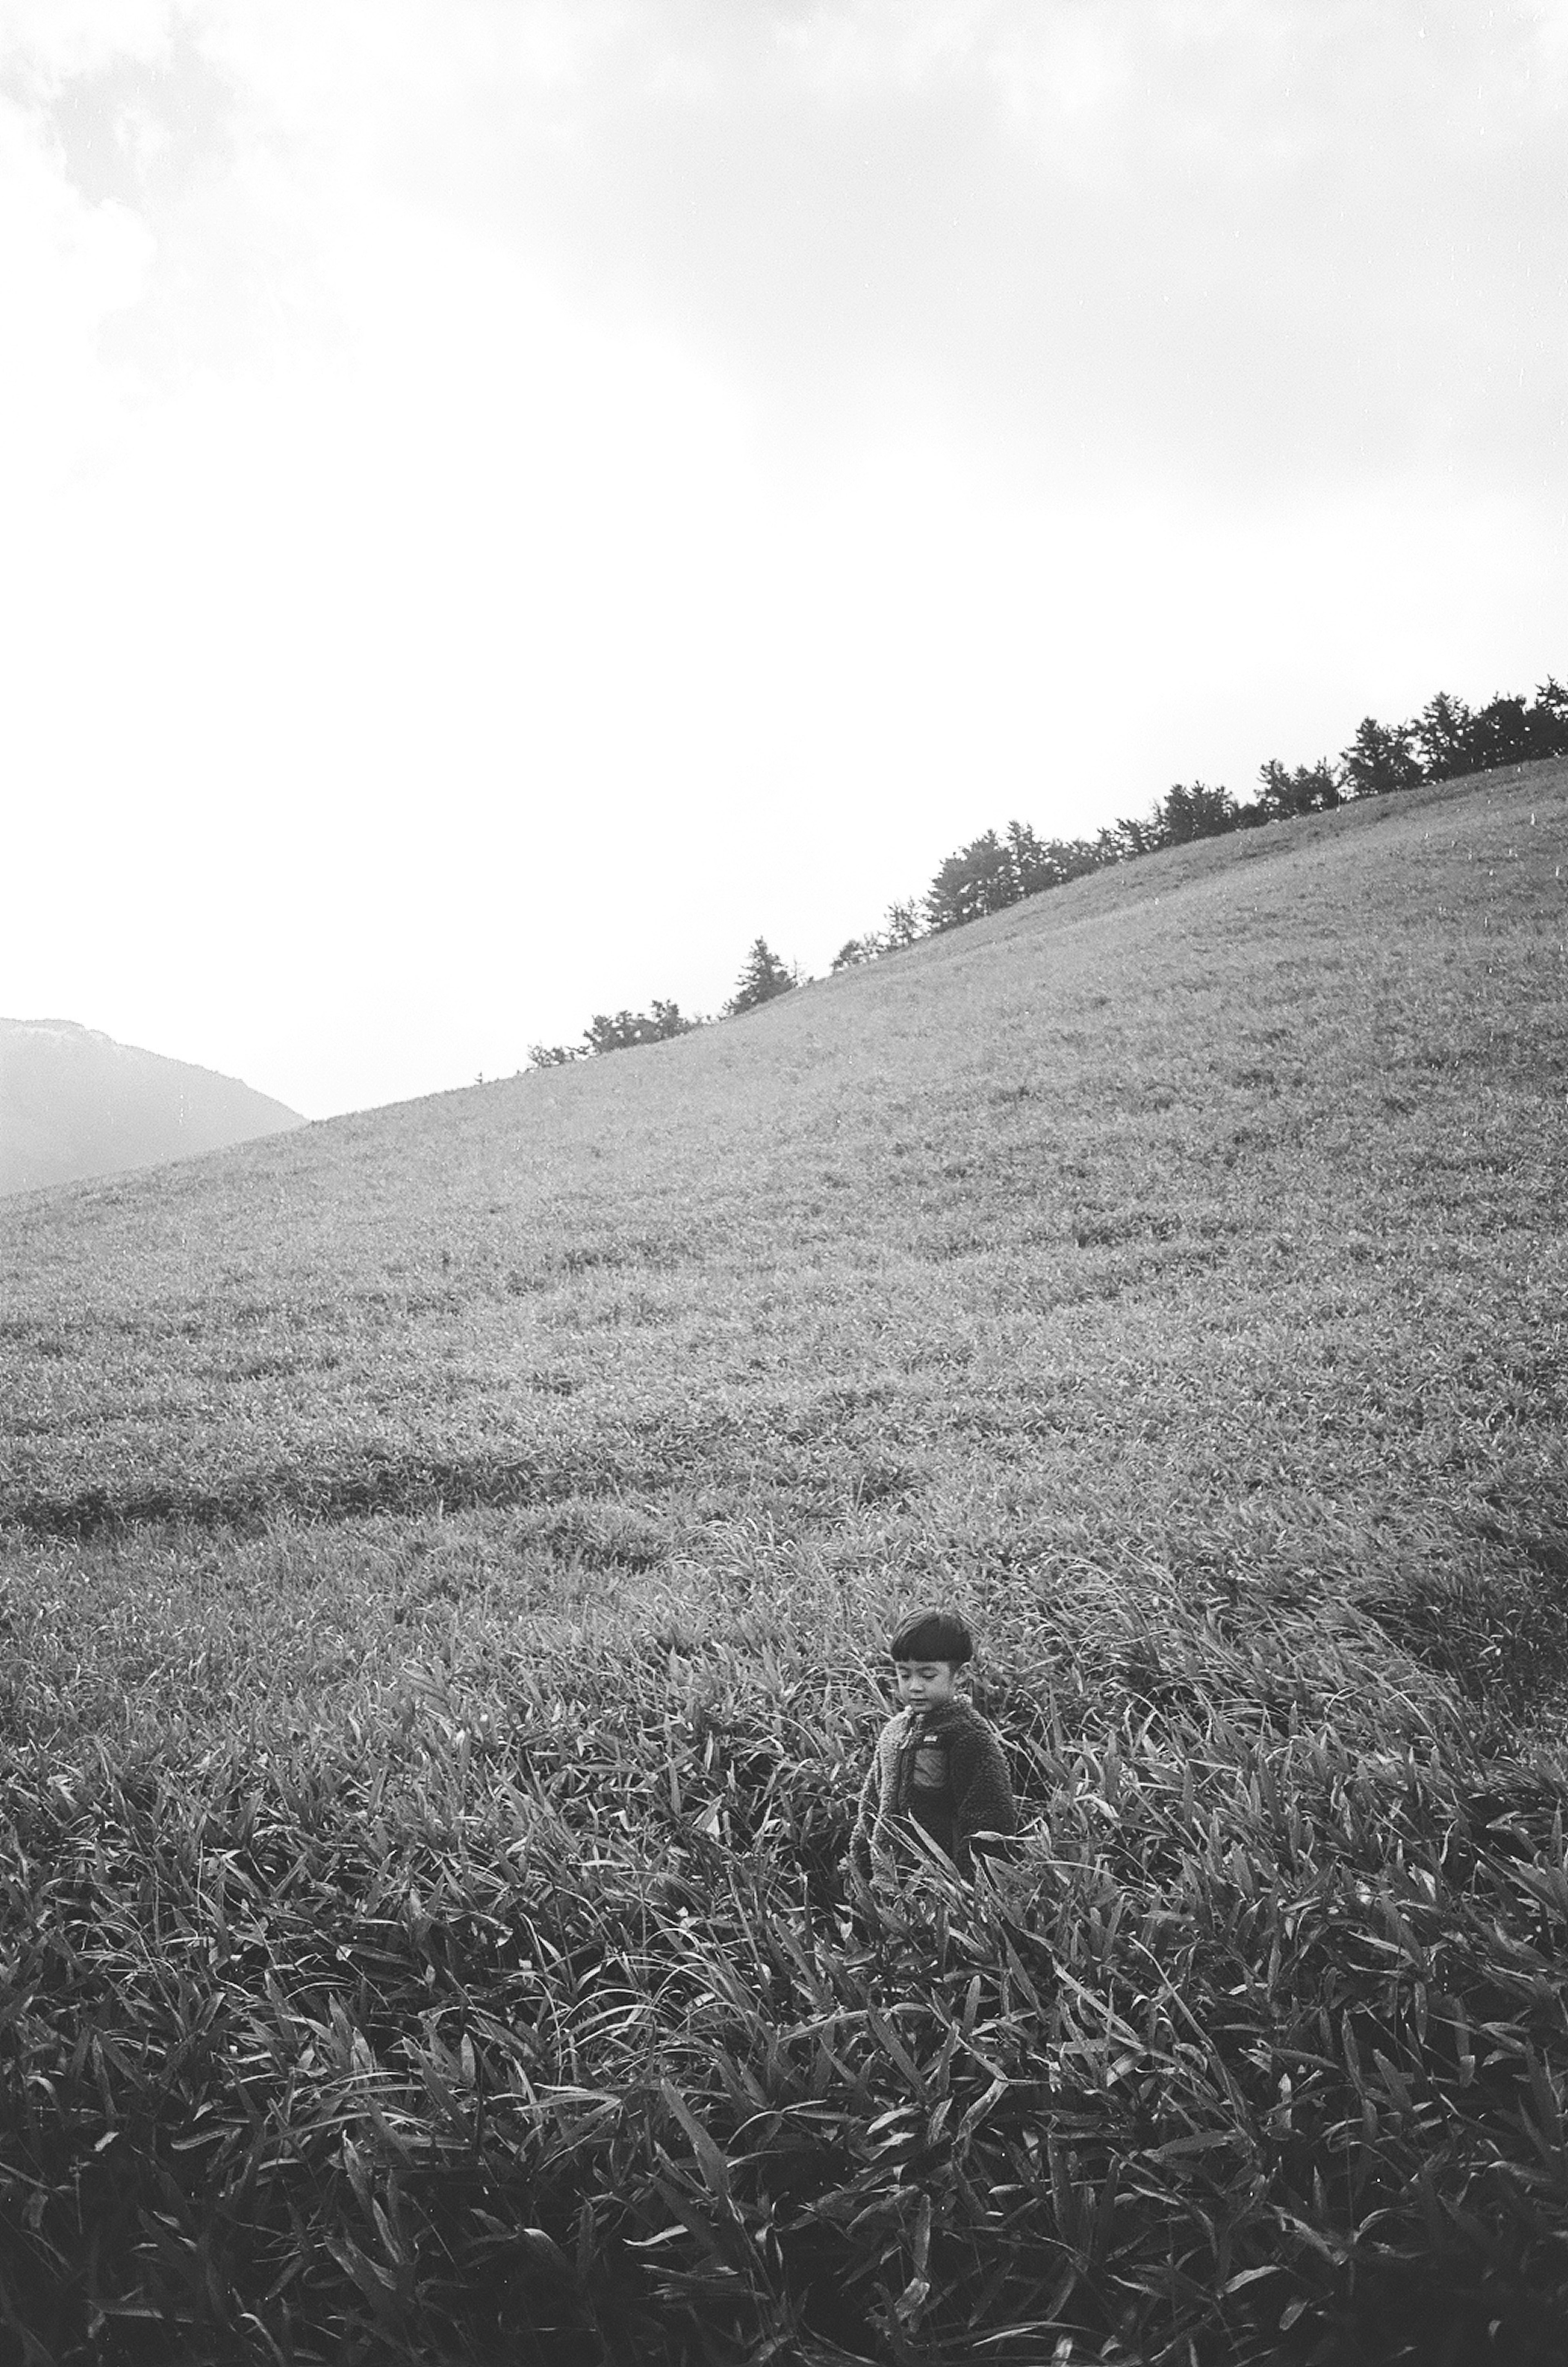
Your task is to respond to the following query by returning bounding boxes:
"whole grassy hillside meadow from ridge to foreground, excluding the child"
[0,762,1568,2367]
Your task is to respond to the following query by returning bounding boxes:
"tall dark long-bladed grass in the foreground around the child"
[0,1614,1568,2367]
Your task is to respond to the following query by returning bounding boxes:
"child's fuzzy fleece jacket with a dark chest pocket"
[849,1702,1017,1877]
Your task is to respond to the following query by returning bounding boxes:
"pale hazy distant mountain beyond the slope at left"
[0,1020,305,1193]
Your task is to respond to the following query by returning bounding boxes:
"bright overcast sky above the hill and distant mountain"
[0,0,1568,1117]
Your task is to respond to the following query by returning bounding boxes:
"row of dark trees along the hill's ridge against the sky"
[528,675,1568,1068]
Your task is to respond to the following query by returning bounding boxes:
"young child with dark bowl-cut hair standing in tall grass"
[849,1612,1017,1879]
